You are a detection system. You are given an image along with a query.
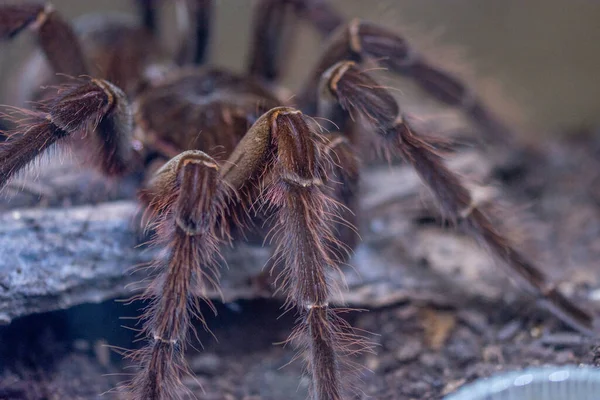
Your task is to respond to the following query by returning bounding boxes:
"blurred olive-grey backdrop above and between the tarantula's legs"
[0,0,600,131]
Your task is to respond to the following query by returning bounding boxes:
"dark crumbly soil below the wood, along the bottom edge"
[0,284,595,400]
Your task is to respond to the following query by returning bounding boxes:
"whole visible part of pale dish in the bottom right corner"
[444,366,600,400]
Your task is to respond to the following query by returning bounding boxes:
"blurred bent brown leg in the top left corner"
[0,2,88,77]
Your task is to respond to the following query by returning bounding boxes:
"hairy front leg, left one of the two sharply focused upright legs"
[125,151,230,400]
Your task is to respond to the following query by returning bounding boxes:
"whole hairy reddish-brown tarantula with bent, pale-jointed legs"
[0,0,597,400]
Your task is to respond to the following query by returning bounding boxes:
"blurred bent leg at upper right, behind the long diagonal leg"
[299,19,513,143]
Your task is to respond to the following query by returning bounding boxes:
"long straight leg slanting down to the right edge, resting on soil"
[322,61,599,336]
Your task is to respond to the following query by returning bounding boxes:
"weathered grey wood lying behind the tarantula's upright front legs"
[0,152,506,324]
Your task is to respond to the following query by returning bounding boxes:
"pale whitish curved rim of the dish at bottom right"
[444,365,600,400]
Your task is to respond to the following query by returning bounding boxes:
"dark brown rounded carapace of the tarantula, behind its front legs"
[134,68,285,160]
